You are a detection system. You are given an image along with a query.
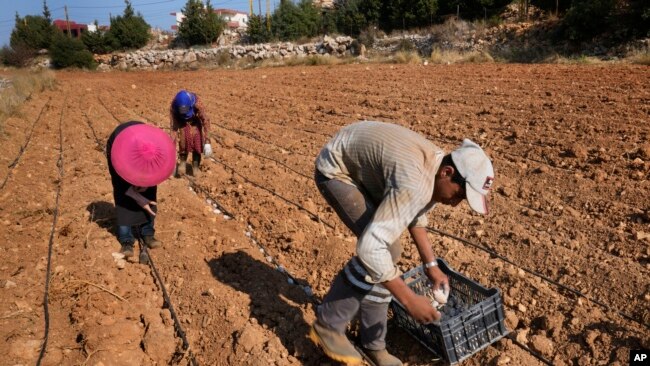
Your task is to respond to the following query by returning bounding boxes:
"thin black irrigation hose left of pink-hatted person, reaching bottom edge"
[36,98,65,366]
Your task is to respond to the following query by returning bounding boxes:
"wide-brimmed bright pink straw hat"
[111,124,176,187]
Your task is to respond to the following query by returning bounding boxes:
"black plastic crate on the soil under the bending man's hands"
[391,259,508,365]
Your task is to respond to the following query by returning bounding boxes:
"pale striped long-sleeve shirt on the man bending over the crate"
[316,121,444,291]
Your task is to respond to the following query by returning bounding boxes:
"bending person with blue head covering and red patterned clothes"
[169,89,212,176]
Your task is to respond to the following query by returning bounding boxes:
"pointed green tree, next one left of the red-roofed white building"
[108,0,151,49]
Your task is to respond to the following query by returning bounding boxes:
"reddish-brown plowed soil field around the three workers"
[0,64,650,365]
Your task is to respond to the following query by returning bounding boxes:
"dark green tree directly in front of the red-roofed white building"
[178,0,226,46]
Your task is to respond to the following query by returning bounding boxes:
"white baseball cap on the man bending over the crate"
[451,139,494,215]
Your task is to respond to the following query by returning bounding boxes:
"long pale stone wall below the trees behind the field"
[95,36,354,70]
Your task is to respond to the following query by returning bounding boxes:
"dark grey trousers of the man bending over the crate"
[315,170,388,350]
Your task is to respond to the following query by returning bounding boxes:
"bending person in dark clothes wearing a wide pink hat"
[106,121,176,258]
